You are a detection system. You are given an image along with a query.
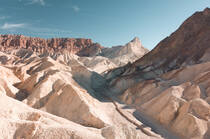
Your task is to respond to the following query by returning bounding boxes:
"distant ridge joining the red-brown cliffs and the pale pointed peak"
[0,35,148,73]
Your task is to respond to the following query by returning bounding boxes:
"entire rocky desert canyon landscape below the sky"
[0,8,210,139]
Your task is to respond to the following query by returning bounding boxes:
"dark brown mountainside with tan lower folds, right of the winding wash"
[105,8,210,139]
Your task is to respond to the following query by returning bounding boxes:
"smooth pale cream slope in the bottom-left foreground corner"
[0,93,103,139]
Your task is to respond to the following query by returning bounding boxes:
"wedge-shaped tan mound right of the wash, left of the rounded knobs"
[142,86,184,125]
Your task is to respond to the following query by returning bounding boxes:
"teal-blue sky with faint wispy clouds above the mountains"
[0,0,210,50]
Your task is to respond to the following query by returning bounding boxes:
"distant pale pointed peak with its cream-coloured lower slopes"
[79,37,149,73]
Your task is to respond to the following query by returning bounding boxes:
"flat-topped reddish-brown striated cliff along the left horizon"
[0,35,102,56]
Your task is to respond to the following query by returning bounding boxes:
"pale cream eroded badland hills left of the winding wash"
[0,49,161,139]
